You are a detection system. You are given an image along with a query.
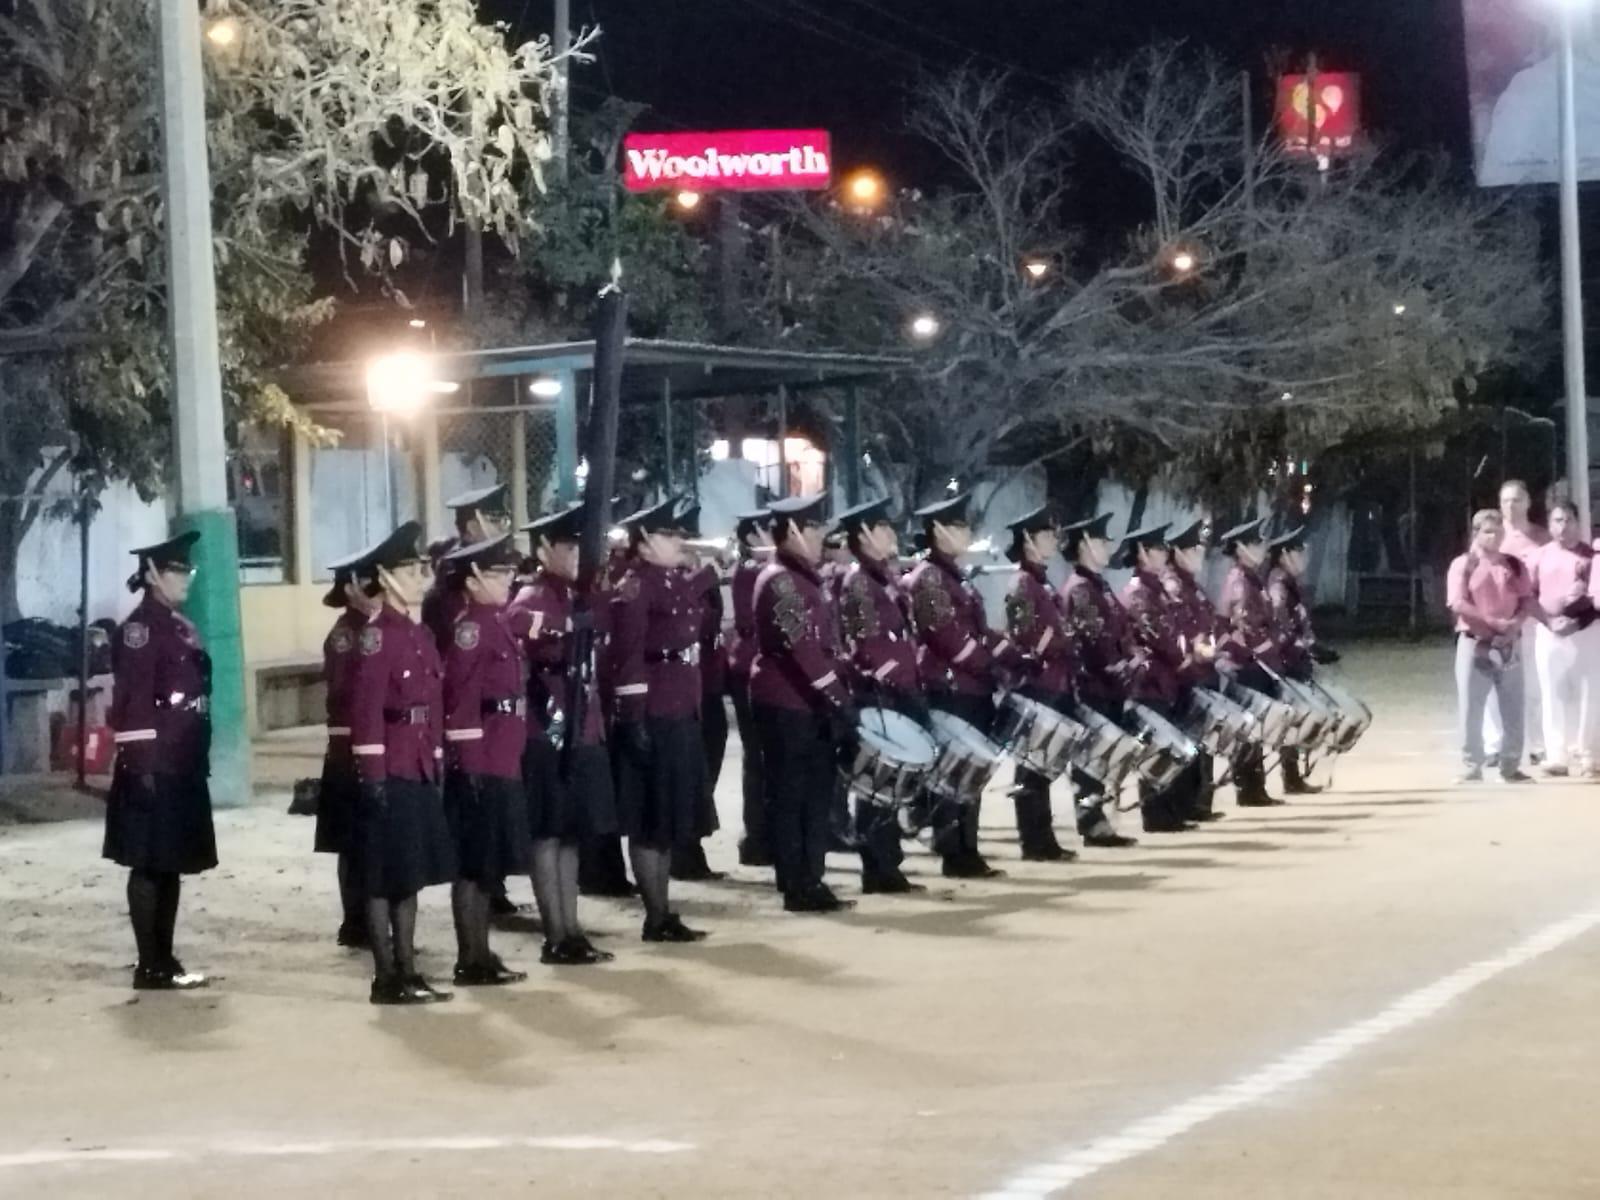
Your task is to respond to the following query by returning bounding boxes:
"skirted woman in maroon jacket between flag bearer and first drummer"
[610,498,710,942]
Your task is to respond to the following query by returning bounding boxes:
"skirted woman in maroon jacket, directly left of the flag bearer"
[442,533,530,987]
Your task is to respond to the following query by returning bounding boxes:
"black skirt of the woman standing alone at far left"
[101,763,216,875]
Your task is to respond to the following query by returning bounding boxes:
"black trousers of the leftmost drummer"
[750,704,837,898]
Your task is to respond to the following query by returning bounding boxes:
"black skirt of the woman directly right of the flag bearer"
[613,717,715,850]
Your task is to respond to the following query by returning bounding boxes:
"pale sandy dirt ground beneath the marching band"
[0,643,1600,1200]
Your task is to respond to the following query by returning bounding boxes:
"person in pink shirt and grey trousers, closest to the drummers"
[1445,509,1533,782]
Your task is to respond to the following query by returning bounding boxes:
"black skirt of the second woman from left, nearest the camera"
[355,779,456,899]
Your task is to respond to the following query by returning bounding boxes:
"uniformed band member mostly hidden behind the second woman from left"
[312,550,382,949]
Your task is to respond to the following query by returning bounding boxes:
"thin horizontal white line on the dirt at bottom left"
[0,1136,696,1170]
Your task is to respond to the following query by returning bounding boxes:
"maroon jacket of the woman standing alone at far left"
[110,594,211,774]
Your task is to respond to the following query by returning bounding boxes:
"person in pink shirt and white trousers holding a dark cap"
[1525,502,1600,776]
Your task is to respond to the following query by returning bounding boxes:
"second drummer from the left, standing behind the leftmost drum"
[837,499,928,896]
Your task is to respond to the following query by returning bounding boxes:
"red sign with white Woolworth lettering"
[622,130,834,192]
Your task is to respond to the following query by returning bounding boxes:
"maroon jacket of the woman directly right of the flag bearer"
[608,558,701,723]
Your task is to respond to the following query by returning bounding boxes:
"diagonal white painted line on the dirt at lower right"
[981,907,1600,1200]
